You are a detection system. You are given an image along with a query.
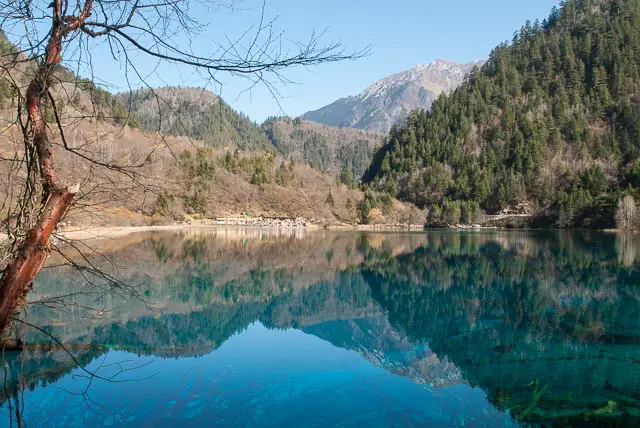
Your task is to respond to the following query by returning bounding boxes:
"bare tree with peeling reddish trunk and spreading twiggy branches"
[0,0,366,332]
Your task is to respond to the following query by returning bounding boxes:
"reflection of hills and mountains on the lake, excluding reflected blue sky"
[0,230,640,426]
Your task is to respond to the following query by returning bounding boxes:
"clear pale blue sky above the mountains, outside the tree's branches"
[79,0,558,122]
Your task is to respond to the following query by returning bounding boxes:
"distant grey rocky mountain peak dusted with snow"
[302,60,482,133]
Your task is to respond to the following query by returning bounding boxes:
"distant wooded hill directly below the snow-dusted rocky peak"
[262,117,384,177]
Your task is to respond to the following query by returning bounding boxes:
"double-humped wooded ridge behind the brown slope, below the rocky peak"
[119,87,384,178]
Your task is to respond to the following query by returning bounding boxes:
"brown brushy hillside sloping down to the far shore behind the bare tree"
[0,105,424,226]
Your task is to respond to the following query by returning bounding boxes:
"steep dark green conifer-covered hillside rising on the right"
[364,0,640,227]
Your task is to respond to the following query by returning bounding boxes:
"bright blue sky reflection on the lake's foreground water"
[10,323,510,427]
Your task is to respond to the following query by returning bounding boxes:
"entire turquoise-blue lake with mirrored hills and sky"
[0,229,640,427]
